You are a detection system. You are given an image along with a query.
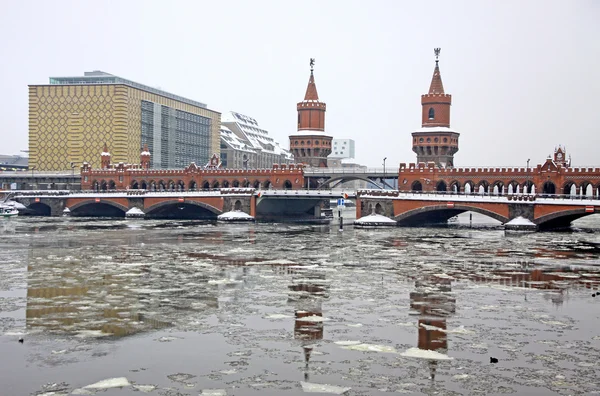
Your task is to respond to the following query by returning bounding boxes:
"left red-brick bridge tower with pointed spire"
[290,58,333,168]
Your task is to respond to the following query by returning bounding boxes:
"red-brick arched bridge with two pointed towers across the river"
[0,53,600,229]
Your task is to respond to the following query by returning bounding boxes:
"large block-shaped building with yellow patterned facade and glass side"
[29,71,221,171]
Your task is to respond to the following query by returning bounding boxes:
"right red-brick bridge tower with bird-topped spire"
[412,48,460,168]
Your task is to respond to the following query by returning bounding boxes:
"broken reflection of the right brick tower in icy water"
[410,275,456,380]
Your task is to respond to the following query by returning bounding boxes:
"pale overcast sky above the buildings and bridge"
[0,0,600,167]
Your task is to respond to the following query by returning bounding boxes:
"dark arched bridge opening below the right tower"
[394,204,508,227]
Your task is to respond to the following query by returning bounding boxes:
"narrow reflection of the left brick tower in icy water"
[288,269,329,381]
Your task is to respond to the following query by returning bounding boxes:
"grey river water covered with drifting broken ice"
[0,210,600,396]
